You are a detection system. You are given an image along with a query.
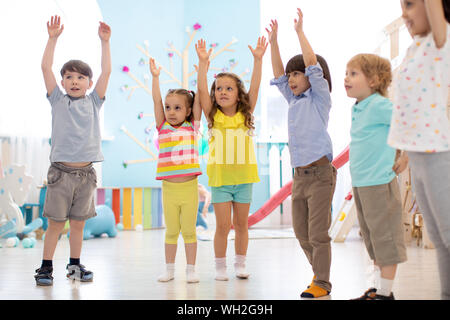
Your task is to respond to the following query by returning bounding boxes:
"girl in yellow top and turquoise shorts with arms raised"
[195,37,267,281]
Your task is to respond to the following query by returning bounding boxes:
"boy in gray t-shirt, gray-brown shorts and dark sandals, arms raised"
[34,16,111,286]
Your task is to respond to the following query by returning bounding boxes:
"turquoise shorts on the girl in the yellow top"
[211,183,253,203]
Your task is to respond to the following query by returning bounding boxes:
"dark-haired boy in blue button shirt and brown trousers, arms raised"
[266,9,336,298]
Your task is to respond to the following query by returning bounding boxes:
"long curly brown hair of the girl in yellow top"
[208,72,255,130]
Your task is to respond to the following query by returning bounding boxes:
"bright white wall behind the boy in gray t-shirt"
[0,0,102,137]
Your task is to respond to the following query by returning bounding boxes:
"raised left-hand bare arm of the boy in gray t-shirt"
[41,16,64,95]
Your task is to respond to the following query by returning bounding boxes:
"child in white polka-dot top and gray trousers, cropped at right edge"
[388,0,450,299]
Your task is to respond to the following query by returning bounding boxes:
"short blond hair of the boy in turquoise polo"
[347,53,392,97]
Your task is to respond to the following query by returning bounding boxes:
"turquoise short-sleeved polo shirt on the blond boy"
[350,93,395,187]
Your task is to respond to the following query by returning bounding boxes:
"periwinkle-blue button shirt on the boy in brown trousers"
[270,63,333,168]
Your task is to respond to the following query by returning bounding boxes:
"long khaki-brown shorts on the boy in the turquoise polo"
[353,178,406,267]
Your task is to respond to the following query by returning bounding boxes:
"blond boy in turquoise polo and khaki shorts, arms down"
[345,54,408,300]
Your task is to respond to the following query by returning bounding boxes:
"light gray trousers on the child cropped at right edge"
[408,151,450,300]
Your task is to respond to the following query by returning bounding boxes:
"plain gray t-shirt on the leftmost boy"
[47,86,105,162]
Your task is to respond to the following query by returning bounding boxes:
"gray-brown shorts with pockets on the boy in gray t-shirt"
[43,162,97,222]
